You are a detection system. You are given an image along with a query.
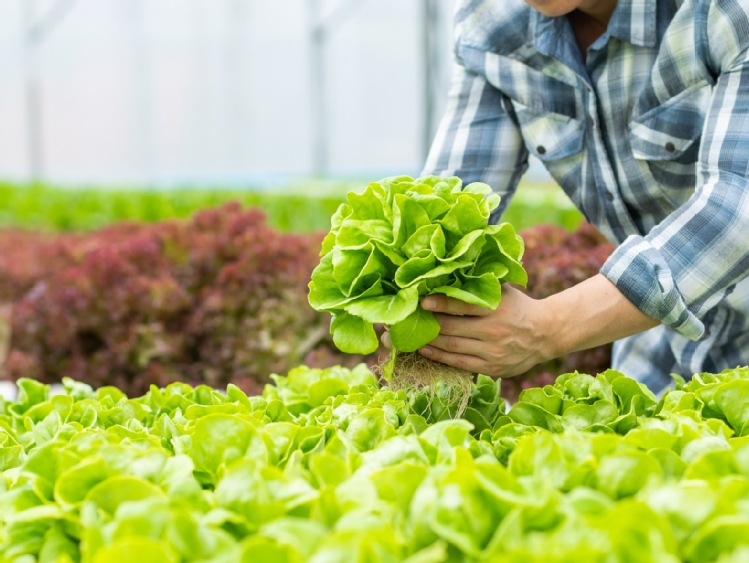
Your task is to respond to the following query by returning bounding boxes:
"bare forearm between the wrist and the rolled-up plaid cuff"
[542,274,660,357]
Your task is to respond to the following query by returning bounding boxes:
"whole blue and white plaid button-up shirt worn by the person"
[423,0,749,391]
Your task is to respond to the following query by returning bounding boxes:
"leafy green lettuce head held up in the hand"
[309,176,527,354]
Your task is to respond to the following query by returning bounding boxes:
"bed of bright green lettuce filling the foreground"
[0,366,749,563]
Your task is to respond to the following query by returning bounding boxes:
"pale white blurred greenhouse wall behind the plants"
[0,0,462,186]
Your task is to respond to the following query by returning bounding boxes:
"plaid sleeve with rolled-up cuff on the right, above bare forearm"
[601,29,749,340]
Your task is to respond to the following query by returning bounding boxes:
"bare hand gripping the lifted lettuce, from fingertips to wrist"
[383,285,555,377]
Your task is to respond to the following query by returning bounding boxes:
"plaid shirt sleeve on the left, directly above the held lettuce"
[421,63,528,222]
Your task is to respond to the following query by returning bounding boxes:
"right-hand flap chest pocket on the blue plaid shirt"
[629,82,711,199]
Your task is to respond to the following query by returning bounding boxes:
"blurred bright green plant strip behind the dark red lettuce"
[0,179,582,233]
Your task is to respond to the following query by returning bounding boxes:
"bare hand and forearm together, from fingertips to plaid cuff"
[419,274,659,377]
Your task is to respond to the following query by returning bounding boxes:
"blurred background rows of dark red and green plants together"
[0,182,611,400]
